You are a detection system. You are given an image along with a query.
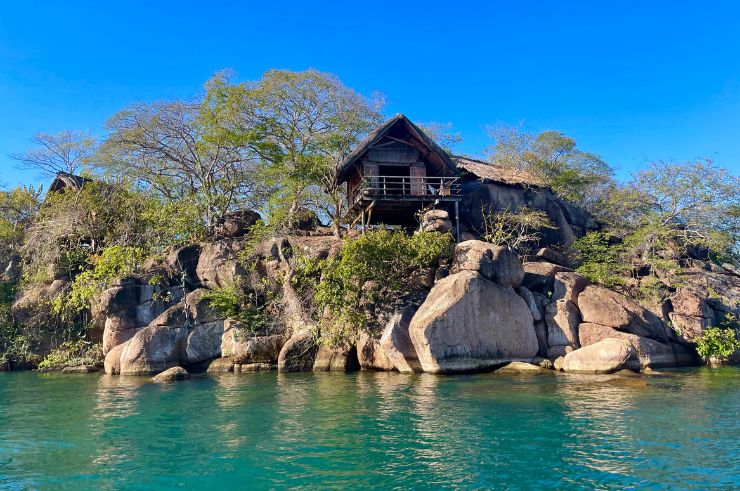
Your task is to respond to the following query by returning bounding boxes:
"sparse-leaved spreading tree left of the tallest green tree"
[96,93,259,234]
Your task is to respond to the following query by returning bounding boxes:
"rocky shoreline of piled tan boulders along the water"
[17,212,740,378]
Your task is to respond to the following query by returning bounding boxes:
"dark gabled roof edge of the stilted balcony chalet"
[338,113,457,182]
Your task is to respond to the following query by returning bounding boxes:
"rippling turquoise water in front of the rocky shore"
[0,368,740,490]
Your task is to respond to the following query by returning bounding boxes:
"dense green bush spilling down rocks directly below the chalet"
[310,229,452,346]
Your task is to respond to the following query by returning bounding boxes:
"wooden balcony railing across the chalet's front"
[354,176,461,201]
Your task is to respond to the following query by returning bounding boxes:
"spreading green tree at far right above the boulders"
[574,159,740,298]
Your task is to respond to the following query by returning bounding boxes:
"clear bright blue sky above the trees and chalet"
[0,0,740,189]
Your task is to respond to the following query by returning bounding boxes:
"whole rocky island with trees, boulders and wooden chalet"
[0,76,740,380]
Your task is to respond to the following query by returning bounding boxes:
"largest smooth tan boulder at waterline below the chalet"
[409,271,538,373]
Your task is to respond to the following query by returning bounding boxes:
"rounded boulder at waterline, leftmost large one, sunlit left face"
[120,325,188,375]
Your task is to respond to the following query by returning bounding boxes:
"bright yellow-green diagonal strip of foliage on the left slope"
[51,246,145,321]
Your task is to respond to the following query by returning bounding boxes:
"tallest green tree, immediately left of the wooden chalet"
[206,69,382,234]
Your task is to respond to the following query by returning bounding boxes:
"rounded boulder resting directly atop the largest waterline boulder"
[450,240,524,288]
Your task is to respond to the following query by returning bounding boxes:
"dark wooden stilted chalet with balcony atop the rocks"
[339,114,461,236]
